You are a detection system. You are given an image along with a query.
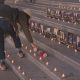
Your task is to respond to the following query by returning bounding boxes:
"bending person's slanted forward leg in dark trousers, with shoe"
[0,19,24,57]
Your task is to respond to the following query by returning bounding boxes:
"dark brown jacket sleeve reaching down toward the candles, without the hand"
[17,11,33,43]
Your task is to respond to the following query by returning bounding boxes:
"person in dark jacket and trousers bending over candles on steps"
[0,4,37,70]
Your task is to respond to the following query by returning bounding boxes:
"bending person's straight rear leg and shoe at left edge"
[0,18,13,70]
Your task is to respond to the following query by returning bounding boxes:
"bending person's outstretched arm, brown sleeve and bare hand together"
[18,12,37,51]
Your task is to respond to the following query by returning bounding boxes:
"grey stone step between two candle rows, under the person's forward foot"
[6,38,57,80]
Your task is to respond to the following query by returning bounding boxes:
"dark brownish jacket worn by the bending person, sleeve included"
[0,4,33,43]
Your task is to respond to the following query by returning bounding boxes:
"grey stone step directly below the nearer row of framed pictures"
[32,33,80,71]
